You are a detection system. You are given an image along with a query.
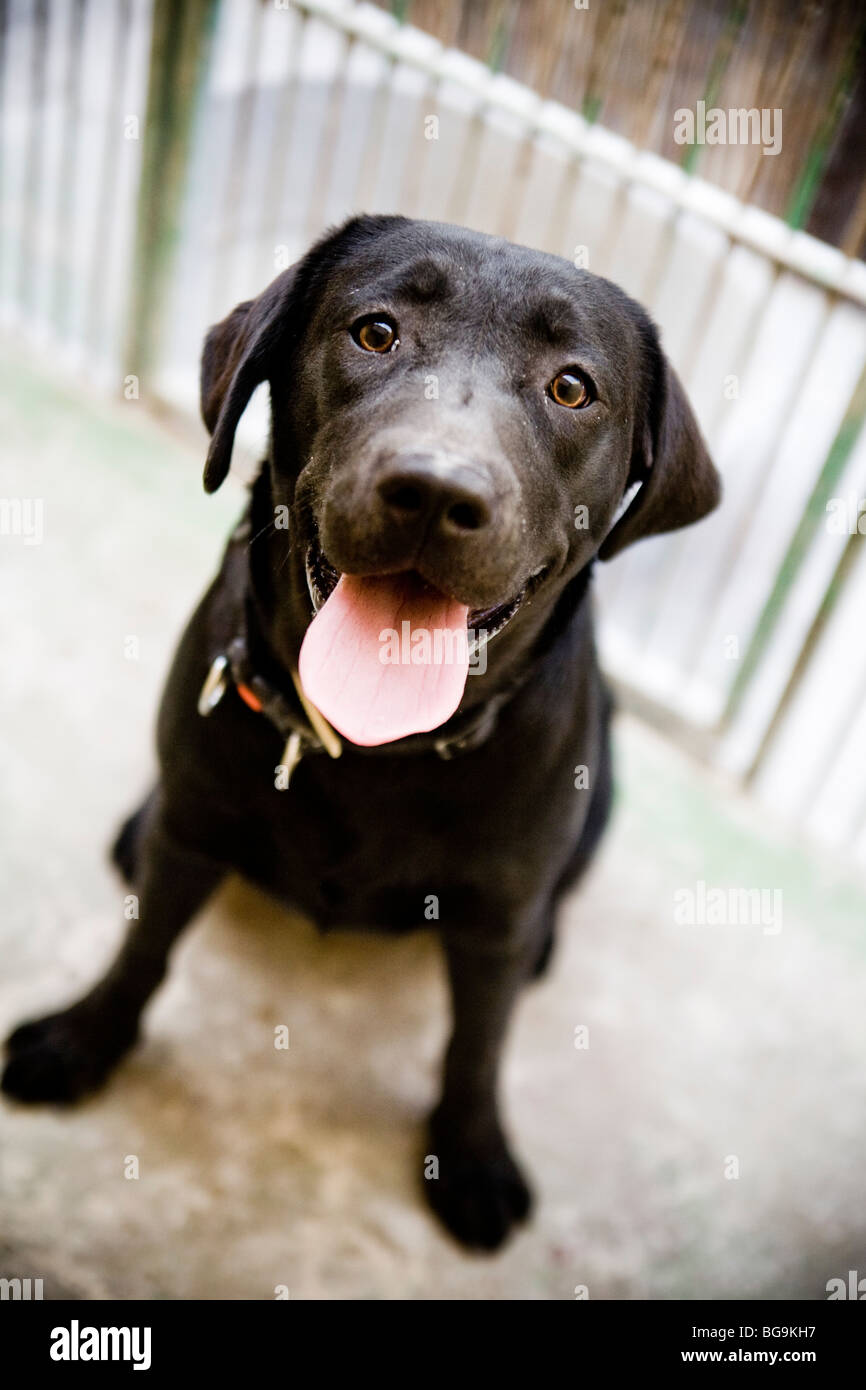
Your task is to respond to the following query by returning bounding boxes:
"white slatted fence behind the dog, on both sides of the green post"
[0,0,866,865]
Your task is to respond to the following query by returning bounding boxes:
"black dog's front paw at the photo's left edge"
[0,1008,136,1104]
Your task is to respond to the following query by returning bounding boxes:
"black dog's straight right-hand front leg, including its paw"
[425,915,541,1250]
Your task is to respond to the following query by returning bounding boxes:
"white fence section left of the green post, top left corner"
[0,0,150,388]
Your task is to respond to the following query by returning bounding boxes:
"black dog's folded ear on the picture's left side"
[200,268,296,492]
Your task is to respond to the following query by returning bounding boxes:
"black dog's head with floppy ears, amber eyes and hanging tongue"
[202,217,720,744]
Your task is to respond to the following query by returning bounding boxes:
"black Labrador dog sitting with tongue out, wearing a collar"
[3,217,719,1248]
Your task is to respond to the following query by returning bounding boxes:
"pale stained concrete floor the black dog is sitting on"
[0,354,866,1300]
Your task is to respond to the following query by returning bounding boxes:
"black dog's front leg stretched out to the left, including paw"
[3,806,225,1101]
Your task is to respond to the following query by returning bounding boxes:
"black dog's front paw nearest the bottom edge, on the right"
[424,1141,532,1251]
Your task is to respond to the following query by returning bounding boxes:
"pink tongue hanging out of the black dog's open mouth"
[299,574,468,748]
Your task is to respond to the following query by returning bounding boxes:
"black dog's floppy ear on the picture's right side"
[599,324,721,560]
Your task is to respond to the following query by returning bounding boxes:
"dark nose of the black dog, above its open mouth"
[377,453,496,539]
